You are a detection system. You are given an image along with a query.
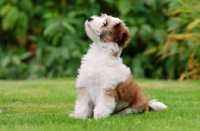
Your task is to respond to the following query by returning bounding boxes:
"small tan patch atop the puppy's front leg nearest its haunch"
[104,88,118,102]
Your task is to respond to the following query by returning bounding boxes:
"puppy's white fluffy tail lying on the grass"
[149,99,168,111]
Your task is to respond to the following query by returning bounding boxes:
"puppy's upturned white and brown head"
[85,14,130,48]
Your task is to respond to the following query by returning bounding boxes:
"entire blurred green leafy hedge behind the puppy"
[0,0,200,80]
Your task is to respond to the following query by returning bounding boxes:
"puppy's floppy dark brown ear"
[112,22,131,48]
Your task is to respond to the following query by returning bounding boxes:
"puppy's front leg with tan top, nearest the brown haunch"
[94,89,117,119]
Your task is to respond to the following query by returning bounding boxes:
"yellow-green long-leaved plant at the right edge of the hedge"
[145,0,200,80]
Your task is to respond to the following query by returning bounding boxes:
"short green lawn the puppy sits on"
[0,78,200,131]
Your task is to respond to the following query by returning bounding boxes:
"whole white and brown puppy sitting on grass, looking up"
[70,14,167,119]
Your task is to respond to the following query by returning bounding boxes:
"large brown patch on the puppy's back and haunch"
[115,75,149,112]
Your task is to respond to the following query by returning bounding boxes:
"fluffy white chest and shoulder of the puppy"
[78,53,130,88]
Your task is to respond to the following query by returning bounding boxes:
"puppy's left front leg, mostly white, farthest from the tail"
[70,87,93,119]
